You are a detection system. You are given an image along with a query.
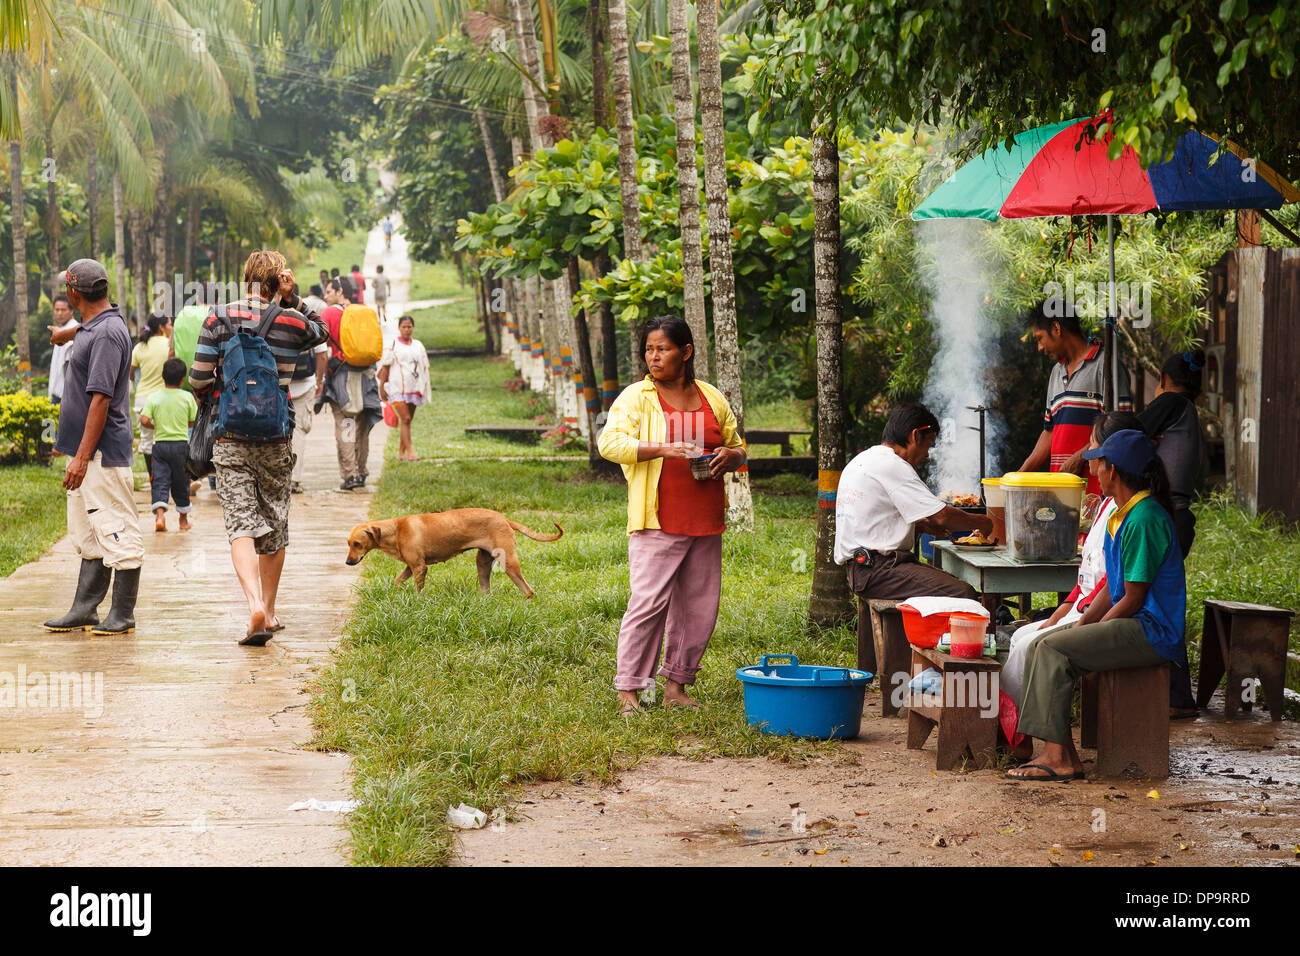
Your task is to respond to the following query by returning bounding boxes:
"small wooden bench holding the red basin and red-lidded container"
[907,646,1003,770]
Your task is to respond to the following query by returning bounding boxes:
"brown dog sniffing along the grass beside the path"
[347,507,564,597]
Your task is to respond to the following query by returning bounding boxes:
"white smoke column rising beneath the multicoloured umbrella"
[915,219,1005,494]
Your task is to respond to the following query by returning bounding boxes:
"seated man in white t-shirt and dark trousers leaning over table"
[835,402,1006,655]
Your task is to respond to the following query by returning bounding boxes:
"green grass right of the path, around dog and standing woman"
[313,359,854,864]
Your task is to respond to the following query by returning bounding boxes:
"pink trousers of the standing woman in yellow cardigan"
[614,529,723,691]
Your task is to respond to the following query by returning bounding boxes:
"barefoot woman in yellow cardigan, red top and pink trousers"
[599,315,746,714]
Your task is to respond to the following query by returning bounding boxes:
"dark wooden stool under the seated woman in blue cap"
[1079,663,1169,777]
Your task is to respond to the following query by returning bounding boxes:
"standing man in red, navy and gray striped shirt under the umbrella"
[1021,299,1134,494]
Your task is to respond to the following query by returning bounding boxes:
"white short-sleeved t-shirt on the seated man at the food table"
[835,445,944,564]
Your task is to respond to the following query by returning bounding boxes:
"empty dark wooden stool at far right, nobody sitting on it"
[1196,601,1295,721]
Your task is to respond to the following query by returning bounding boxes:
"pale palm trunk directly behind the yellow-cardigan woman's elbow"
[696,0,754,531]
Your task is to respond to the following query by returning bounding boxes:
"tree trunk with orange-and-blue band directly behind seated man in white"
[809,120,853,627]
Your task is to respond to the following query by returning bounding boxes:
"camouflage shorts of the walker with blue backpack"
[212,441,294,554]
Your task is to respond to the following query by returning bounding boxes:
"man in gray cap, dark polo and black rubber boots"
[46,259,144,635]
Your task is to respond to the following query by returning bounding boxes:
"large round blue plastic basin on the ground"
[736,654,871,740]
